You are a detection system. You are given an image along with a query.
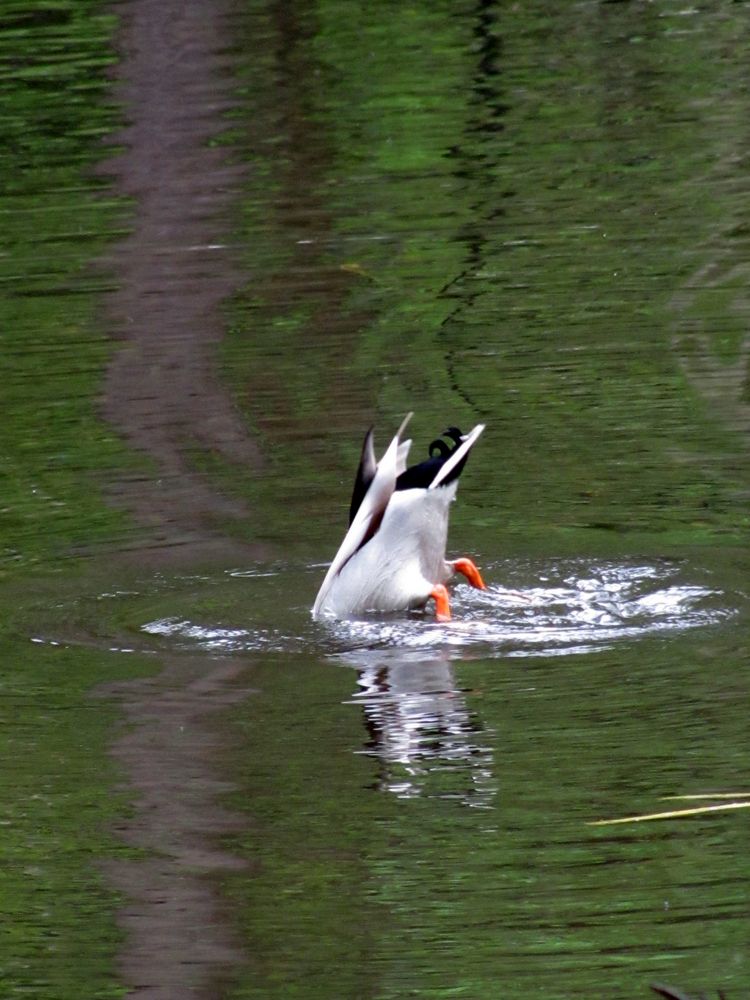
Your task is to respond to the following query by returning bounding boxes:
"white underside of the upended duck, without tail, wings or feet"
[313,481,458,618]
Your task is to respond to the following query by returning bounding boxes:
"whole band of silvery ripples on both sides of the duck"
[141,560,736,662]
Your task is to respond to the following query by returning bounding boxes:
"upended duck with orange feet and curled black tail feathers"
[312,413,485,622]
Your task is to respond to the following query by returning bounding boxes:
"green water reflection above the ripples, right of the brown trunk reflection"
[227,4,747,547]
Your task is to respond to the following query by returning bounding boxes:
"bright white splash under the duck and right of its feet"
[330,562,734,660]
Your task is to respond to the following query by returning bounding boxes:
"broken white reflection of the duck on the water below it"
[346,650,496,809]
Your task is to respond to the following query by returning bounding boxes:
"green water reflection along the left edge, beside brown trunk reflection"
[0,0,143,1000]
